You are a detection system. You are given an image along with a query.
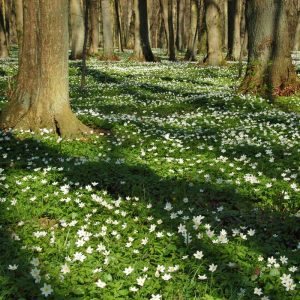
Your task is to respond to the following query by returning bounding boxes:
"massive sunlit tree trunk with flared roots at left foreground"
[0,0,89,137]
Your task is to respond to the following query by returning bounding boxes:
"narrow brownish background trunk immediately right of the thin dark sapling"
[89,0,99,55]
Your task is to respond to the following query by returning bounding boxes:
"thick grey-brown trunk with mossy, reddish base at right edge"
[240,0,299,99]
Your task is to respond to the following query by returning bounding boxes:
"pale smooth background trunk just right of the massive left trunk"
[70,0,84,59]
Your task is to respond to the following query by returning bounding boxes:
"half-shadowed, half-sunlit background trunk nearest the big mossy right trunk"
[227,0,244,61]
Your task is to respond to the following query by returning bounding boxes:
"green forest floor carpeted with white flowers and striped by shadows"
[0,52,300,300]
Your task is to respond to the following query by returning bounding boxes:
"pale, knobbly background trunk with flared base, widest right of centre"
[204,0,223,66]
